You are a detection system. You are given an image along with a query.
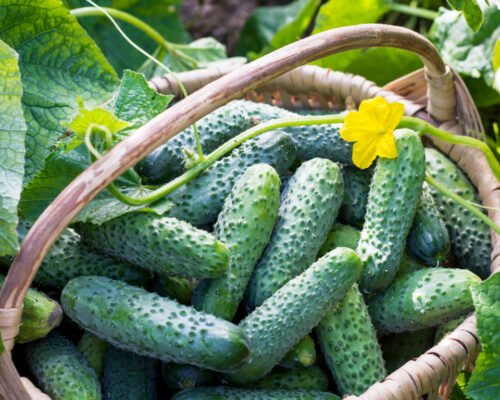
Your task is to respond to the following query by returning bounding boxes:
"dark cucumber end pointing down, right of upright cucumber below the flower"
[406,182,450,267]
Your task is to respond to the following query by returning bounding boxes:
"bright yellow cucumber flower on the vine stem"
[340,96,404,169]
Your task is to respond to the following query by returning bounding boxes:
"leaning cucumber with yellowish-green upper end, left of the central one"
[193,164,280,321]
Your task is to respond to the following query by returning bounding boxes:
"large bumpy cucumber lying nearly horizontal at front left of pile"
[61,276,249,371]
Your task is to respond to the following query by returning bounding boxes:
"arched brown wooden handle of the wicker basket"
[0,24,454,400]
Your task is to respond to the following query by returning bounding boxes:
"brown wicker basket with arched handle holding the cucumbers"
[0,24,500,400]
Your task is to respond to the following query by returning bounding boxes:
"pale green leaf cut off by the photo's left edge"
[0,40,26,256]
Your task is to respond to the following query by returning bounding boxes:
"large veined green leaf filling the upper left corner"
[0,0,118,182]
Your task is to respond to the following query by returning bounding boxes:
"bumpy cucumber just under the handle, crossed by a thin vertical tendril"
[138,102,255,183]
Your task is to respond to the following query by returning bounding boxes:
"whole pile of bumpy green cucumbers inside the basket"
[1,101,491,400]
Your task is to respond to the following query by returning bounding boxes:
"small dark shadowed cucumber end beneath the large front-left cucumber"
[162,363,217,391]
